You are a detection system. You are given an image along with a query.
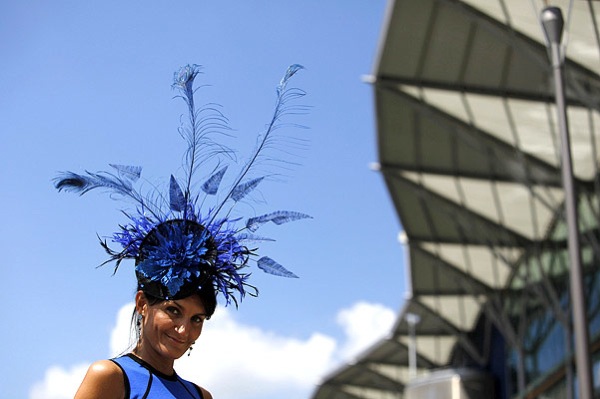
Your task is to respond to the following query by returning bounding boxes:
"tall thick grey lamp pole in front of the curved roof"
[541,7,593,399]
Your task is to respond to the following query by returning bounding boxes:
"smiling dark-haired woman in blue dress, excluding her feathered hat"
[75,290,214,399]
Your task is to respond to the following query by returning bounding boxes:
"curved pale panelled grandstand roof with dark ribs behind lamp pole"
[313,0,600,399]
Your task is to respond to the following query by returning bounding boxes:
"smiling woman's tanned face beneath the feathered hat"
[136,292,207,360]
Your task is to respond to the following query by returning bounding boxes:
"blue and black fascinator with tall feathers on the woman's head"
[54,65,310,305]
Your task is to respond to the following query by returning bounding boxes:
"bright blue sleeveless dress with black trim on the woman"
[110,354,203,399]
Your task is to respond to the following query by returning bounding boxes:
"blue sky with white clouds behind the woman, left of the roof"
[0,0,406,399]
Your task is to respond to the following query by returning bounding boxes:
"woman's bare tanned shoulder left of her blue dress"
[75,360,125,399]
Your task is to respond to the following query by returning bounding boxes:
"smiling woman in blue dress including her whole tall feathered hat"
[55,65,309,399]
